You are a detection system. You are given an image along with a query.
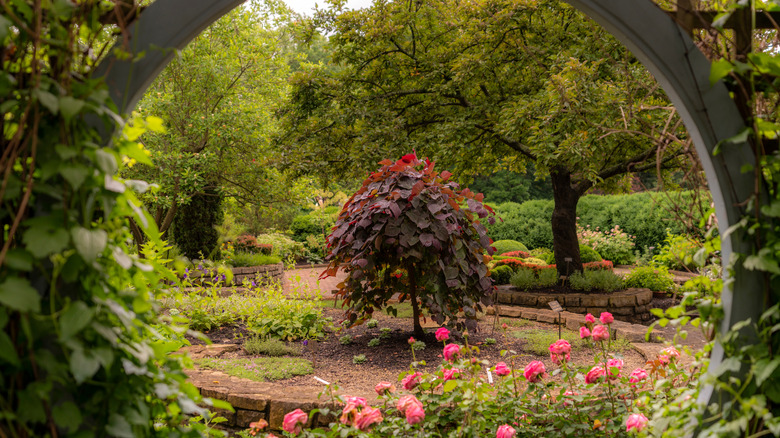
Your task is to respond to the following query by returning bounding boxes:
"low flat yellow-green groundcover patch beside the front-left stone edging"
[195,357,314,382]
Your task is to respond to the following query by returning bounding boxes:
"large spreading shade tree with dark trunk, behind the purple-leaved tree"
[278,0,689,275]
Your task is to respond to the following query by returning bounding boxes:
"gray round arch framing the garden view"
[96,0,763,410]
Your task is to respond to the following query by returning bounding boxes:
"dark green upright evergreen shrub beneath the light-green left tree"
[173,187,223,260]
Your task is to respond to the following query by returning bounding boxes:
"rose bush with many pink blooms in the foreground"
[253,314,698,438]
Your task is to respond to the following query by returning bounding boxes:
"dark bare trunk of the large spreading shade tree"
[550,167,582,276]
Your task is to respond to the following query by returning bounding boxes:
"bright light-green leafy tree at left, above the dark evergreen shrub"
[127,1,300,255]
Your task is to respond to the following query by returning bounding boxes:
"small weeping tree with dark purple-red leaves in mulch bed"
[323,154,494,336]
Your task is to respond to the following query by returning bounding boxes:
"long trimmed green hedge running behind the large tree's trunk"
[485,191,709,250]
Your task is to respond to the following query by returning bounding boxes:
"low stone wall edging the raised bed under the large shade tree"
[496,286,653,323]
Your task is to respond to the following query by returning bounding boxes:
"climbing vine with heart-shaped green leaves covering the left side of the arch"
[0,1,229,437]
